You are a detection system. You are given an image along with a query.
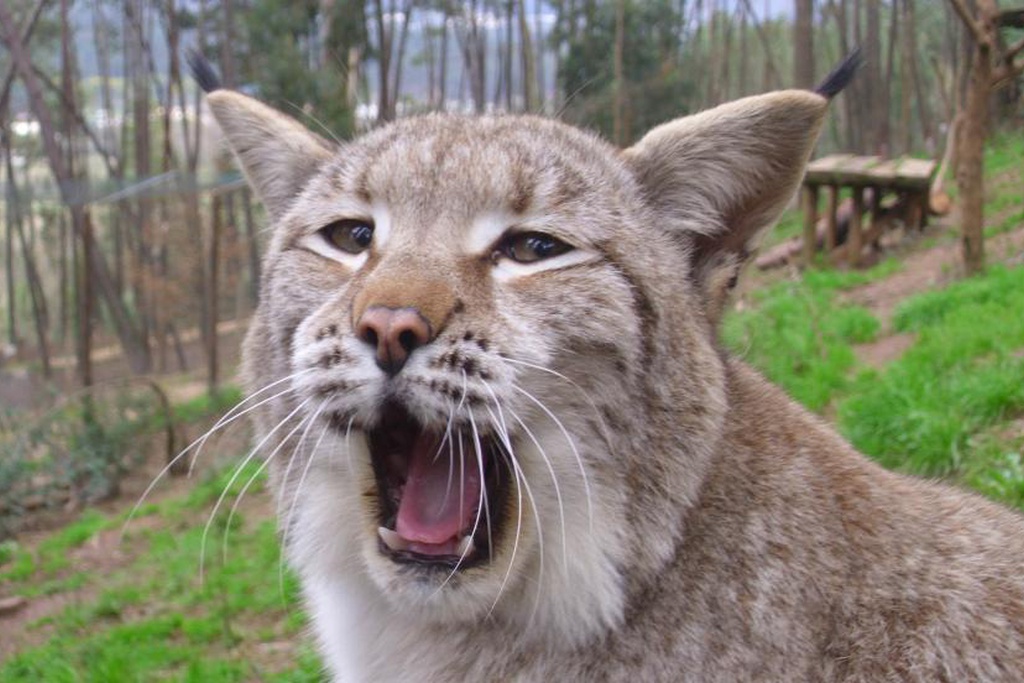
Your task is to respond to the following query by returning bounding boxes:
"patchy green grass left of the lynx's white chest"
[0,464,322,683]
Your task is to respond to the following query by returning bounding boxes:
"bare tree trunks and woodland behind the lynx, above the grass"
[0,0,1024,404]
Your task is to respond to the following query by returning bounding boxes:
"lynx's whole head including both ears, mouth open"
[209,78,827,642]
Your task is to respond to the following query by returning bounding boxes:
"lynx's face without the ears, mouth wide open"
[260,118,667,634]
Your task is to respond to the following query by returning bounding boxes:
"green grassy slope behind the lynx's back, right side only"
[723,135,1024,507]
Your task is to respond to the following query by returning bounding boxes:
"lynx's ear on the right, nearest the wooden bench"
[623,90,828,318]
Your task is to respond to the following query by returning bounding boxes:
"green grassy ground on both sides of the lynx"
[6,136,1024,682]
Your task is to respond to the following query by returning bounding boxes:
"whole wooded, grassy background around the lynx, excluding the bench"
[0,0,1024,680]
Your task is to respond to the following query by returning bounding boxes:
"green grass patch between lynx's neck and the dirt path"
[722,261,899,411]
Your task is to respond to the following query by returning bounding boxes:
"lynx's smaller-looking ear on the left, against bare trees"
[207,90,333,218]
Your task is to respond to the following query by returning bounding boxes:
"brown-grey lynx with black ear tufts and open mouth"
[196,54,1024,682]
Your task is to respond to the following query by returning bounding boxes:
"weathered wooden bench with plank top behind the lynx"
[803,155,936,266]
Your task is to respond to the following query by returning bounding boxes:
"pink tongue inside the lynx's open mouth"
[394,434,480,545]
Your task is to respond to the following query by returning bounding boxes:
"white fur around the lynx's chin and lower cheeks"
[285,423,626,680]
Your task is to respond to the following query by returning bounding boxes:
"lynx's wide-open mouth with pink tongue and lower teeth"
[368,403,509,570]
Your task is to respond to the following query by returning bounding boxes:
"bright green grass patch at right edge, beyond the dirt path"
[839,267,1024,478]
